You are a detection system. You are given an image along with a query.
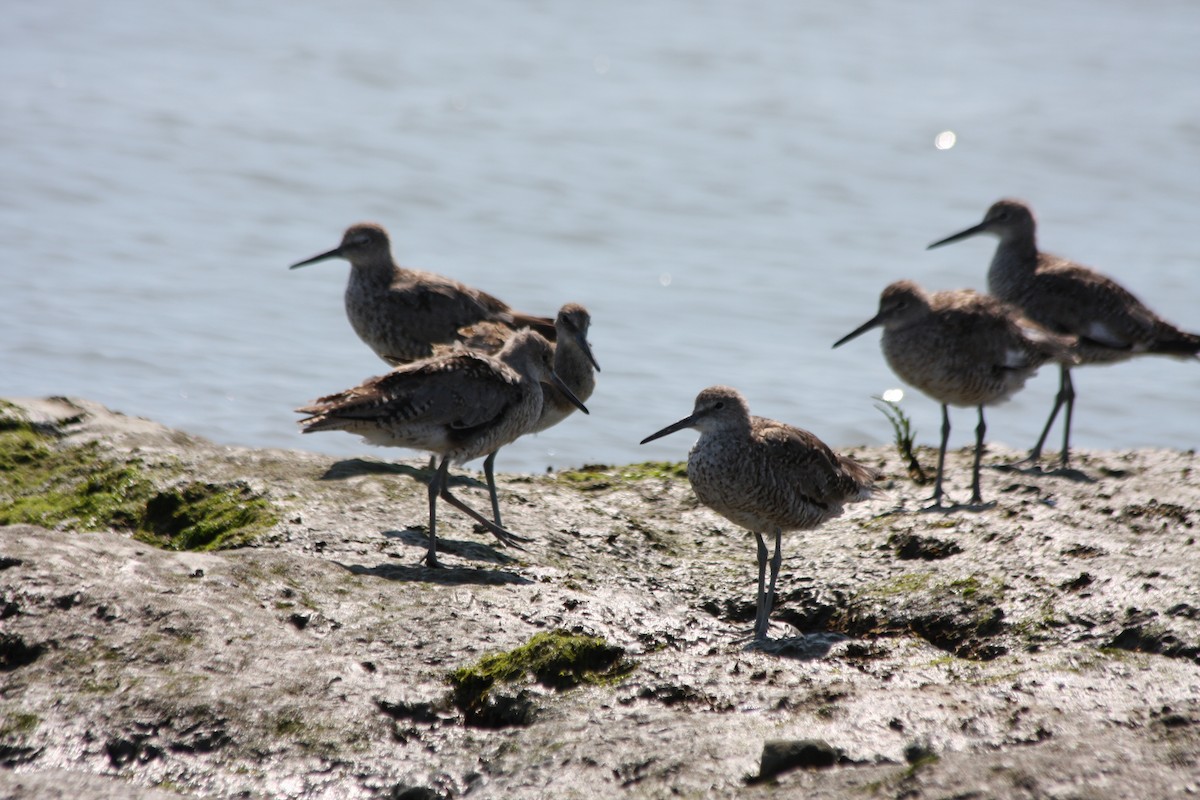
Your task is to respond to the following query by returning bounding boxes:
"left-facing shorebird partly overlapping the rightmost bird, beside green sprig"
[834,281,1075,507]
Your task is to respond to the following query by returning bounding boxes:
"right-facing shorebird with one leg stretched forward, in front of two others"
[296,330,588,567]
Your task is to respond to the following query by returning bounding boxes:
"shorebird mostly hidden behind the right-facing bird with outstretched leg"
[438,302,600,525]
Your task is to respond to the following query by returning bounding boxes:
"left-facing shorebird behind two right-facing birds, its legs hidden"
[290,222,554,366]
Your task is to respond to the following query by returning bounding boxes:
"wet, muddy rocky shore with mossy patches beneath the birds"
[0,398,1200,799]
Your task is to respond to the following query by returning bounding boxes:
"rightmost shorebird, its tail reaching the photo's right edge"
[929,200,1200,468]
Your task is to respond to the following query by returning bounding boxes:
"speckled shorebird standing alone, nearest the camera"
[642,386,878,640]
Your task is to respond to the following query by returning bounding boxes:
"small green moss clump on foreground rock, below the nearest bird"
[449,631,634,718]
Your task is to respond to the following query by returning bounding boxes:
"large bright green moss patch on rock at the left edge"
[0,424,275,549]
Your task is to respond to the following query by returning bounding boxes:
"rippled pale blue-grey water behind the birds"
[0,0,1200,471]
